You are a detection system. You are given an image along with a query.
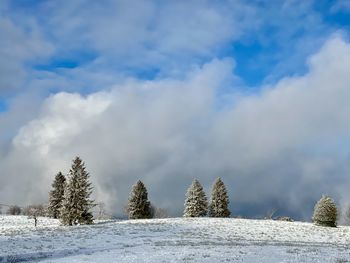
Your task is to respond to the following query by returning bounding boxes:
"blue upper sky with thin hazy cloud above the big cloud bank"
[0,1,350,106]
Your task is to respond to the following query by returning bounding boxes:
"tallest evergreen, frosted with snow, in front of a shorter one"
[60,157,95,225]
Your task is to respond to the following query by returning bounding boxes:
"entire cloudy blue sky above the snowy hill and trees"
[0,0,350,220]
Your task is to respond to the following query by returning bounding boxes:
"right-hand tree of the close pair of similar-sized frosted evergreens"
[209,177,231,217]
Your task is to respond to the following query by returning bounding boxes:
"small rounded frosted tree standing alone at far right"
[312,196,338,227]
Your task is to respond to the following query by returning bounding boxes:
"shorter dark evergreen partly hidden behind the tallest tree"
[47,172,66,218]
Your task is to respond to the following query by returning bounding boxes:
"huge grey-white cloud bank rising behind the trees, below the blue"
[0,35,350,219]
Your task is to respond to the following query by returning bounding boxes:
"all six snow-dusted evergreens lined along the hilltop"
[48,157,338,226]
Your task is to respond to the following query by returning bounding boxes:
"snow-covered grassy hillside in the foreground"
[0,216,350,263]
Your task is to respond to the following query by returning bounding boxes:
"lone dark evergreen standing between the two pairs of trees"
[127,181,151,219]
